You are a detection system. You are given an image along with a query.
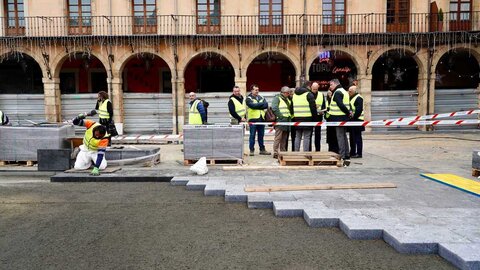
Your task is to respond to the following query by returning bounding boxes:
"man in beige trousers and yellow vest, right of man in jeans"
[272,86,293,158]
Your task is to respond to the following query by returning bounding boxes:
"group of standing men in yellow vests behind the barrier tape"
[189,79,365,165]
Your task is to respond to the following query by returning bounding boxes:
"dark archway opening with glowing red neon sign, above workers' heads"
[308,51,357,92]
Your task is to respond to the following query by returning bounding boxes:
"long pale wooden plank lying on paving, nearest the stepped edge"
[245,183,397,192]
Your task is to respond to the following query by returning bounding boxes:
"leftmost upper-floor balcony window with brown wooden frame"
[3,0,25,35]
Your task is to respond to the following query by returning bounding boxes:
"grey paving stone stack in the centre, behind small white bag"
[183,125,244,160]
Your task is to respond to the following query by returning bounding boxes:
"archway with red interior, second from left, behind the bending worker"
[59,52,108,125]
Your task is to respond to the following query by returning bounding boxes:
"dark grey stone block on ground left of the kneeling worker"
[37,149,73,171]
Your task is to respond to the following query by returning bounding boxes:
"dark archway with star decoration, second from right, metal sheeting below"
[371,49,419,129]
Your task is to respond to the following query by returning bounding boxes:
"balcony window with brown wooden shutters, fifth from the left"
[258,0,283,34]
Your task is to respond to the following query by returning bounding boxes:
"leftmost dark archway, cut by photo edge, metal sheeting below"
[0,52,45,125]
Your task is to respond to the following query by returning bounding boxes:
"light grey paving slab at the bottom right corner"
[438,243,480,270]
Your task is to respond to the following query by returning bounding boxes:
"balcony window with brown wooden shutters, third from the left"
[132,0,157,34]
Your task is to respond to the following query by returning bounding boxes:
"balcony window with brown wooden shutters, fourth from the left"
[197,0,221,34]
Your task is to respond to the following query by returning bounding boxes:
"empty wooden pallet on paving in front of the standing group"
[278,152,343,167]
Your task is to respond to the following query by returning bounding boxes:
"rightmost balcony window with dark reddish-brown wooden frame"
[448,0,472,31]
